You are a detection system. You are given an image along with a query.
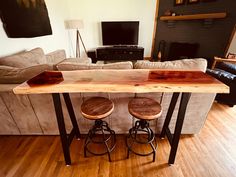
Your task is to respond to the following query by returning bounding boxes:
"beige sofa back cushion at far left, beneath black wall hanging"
[0,48,47,68]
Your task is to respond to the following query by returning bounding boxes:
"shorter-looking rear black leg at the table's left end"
[63,93,81,139]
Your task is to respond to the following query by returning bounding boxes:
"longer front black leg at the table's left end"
[52,93,71,165]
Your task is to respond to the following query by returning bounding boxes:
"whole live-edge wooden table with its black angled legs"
[13,69,229,165]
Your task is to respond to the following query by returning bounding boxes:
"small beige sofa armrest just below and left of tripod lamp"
[46,50,66,64]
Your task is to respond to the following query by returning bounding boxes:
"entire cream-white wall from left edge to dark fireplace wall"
[0,0,156,57]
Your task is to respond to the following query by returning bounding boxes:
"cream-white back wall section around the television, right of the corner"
[67,0,156,56]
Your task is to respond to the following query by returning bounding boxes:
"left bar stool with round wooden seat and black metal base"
[81,97,116,162]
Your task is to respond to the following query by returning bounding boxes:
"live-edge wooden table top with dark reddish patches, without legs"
[13,69,229,94]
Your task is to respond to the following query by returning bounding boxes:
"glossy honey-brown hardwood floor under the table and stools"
[0,103,236,177]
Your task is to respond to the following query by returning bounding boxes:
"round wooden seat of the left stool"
[81,97,114,120]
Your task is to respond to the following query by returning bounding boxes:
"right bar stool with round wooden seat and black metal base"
[126,97,162,162]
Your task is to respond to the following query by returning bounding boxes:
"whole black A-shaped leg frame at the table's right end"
[160,93,191,164]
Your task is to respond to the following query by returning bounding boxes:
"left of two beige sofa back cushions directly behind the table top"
[57,61,133,71]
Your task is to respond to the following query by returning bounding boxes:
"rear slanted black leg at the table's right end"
[160,93,179,138]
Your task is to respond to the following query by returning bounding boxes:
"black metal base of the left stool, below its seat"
[84,120,116,162]
